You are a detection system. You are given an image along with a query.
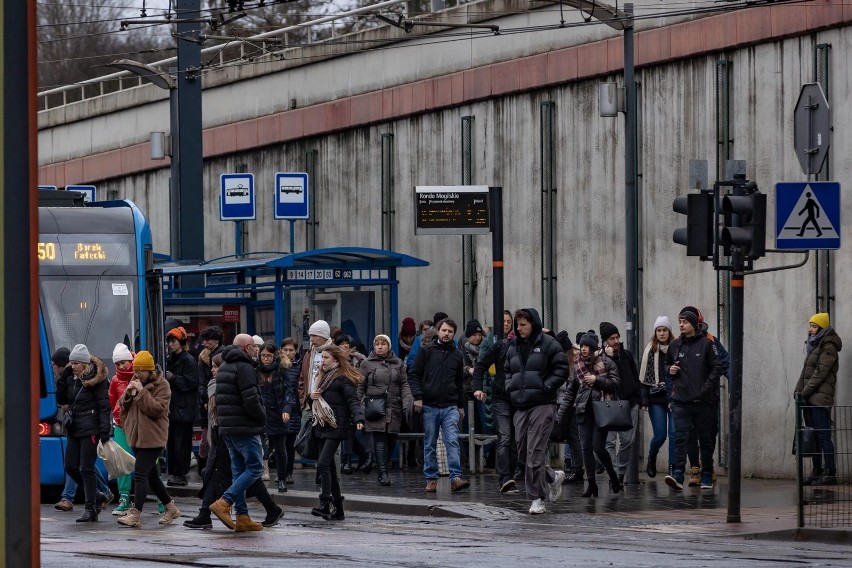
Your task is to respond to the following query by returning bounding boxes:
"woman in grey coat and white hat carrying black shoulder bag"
[358,335,414,485]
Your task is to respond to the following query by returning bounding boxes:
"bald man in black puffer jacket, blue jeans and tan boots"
[210,333,266,532]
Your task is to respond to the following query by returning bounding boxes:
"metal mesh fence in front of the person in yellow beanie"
[793,401,852,528]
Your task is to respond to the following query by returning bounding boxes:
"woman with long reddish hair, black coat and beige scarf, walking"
[310,345,364,520]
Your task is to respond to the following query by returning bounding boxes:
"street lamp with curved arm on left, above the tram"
[106,59,182,259]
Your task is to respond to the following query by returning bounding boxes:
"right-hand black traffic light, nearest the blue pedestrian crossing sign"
[722,192,766,260]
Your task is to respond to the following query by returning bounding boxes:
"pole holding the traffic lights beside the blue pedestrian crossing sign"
[727,175,745,523]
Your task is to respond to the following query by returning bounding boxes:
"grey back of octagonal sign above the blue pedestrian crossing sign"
[793,83,831,175]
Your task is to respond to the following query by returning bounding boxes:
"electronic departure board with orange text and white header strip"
[414,185,491,235]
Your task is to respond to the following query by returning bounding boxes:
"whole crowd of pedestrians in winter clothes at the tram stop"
[52,306,841,532]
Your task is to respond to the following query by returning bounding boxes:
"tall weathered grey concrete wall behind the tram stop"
[36,2,852,477]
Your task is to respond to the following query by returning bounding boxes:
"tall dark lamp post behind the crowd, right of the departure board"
[624,2,639,483]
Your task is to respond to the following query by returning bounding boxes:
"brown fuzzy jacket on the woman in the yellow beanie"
[119,367,172,449]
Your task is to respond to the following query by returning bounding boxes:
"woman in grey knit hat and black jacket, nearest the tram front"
[56,343,111,523]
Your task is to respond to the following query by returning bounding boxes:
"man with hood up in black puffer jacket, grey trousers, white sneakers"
[505,308,568,515]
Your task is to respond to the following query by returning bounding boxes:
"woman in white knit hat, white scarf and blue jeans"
[639,316,674,477]
